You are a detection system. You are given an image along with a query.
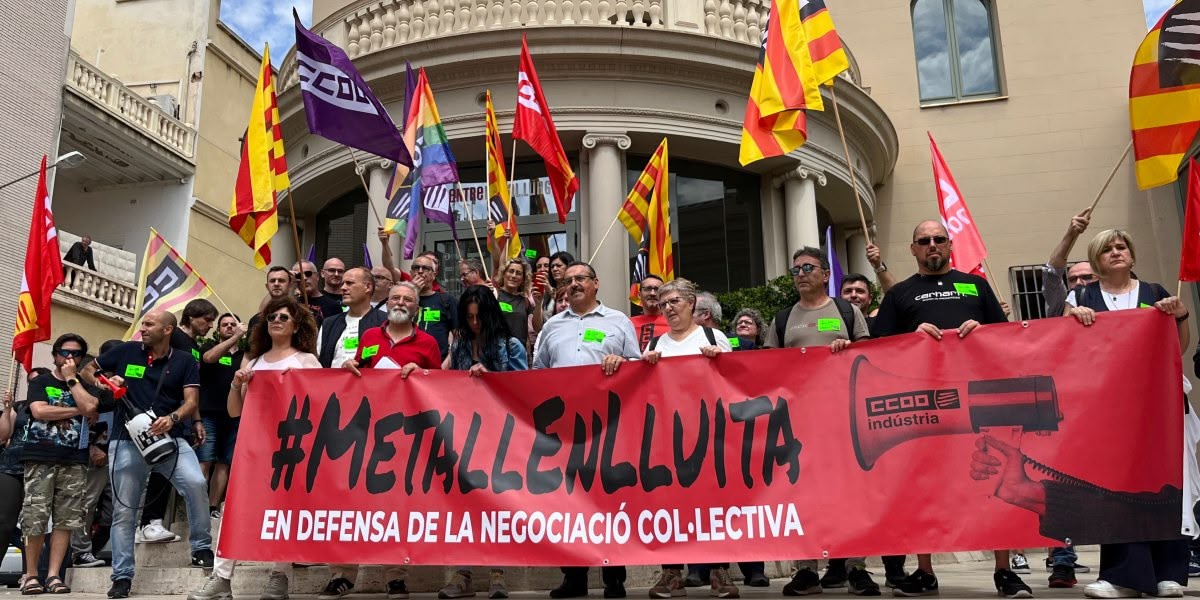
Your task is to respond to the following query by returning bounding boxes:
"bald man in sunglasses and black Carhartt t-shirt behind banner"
[874,221,1033,598]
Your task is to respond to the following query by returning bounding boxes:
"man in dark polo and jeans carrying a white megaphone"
[96,311,212,598]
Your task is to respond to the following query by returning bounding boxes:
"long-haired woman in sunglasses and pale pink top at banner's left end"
[194,296,320,600]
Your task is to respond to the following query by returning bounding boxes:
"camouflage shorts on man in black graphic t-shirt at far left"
[20,462,88,538]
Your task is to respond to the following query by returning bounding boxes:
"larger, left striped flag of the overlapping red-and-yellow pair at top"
[738,0,836,166]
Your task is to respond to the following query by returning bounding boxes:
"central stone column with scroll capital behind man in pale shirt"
[576,133,630,311]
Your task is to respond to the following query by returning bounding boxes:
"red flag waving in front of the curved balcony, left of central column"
[509,35,580,223]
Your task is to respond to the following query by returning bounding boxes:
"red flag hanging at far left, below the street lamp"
[12,156,62,373]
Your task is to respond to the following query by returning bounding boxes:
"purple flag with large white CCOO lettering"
[292,8,413,167]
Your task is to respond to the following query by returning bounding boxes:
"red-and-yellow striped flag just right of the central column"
[617,138,674,300]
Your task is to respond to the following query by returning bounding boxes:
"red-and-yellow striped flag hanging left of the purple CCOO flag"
[229,47,292,270]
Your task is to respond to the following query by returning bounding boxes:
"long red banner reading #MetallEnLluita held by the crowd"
[220,310,1183,565]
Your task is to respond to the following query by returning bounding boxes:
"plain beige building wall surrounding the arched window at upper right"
[829,0,1181,309]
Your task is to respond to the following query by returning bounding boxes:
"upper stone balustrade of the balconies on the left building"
[66,52,196,160]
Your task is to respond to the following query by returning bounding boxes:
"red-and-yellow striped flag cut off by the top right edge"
[1129,0,1200,190]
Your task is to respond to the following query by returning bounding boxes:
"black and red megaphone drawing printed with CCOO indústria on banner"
[850,356,1062,470]
